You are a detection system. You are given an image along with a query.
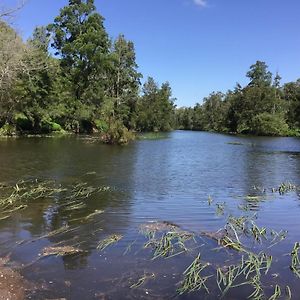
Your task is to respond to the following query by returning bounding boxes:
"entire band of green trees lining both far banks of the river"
[0,0,300,143]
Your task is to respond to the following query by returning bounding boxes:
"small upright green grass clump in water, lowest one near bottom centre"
[177,253,212,295]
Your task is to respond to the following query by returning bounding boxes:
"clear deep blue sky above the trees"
[4,0,300,106]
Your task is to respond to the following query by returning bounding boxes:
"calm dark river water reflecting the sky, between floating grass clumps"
[0,131,300,299]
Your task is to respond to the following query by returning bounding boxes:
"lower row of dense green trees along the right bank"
[176,61,300,136]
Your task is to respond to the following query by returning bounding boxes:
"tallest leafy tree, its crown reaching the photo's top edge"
[48,0,110,104]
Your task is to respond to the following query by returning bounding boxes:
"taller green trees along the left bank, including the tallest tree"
[0,0,175,143]
